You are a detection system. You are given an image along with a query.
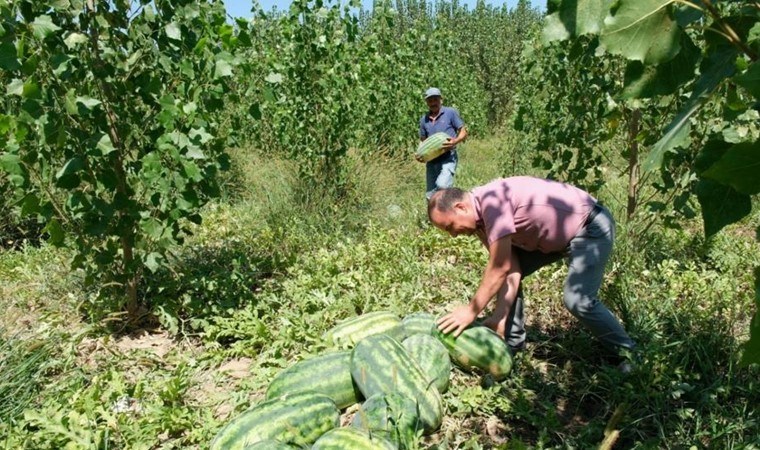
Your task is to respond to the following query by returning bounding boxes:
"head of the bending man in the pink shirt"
[428,188,477,237]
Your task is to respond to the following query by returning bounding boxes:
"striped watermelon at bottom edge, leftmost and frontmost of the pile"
[211,392,340,450]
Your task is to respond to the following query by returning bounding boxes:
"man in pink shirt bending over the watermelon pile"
[428,177,635,360]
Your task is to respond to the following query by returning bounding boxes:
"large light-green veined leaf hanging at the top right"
[599,0,681,64]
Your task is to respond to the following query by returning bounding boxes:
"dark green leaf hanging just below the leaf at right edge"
[697,179,752,238]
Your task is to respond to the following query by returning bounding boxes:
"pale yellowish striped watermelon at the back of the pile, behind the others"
[325,311,405,348]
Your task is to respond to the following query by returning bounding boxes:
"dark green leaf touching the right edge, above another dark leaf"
[702,141,760,195]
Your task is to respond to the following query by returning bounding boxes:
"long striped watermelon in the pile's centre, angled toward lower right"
[351,334,443,433]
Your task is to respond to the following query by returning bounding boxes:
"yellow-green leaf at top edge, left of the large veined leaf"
[542,0,612,42]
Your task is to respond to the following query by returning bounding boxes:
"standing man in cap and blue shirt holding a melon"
[420,87,467,200]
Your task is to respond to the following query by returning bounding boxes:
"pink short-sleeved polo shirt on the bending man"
[472,177,596,253]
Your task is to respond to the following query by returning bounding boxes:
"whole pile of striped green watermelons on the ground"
[211,312,512,450]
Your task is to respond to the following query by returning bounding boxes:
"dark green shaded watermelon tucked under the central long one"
[351,392,422,448]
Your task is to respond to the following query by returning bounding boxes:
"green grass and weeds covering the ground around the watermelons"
[0,136,760,449]
